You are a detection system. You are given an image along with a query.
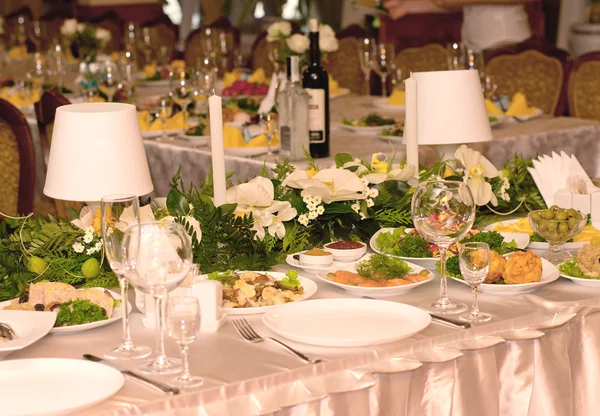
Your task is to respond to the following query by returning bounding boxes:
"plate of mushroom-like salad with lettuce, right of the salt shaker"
[203,270,317,315]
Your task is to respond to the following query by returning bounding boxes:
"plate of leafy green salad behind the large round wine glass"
[369,227,529,270]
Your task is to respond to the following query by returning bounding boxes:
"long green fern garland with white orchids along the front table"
[0,146,545,301]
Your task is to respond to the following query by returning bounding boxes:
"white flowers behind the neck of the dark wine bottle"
[267,21,339,62]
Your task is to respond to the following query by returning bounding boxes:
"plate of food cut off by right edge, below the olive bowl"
[558,239,600,288]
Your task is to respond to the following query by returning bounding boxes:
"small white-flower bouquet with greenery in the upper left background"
[60,19,112,62]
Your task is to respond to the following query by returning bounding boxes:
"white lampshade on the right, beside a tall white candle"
[412,70,493,145]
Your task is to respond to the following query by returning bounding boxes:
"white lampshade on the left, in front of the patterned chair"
[44,103,154,201]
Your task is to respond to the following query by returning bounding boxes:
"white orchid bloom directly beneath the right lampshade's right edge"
[454,144,500,206]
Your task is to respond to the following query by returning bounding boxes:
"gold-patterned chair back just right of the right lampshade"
[485,37,571,116]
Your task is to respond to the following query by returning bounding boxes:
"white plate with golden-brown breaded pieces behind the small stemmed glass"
[446,250,559,295]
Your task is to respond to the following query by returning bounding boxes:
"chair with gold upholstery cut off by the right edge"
[568,52,600,121]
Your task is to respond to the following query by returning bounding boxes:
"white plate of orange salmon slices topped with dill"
[317,254,433,297]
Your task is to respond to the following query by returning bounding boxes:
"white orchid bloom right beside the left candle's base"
[225,176,275,214]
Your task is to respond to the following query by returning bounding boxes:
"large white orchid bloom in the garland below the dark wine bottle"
[299,168,366,204]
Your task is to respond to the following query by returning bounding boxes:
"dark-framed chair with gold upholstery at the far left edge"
[0,99,35,215]
